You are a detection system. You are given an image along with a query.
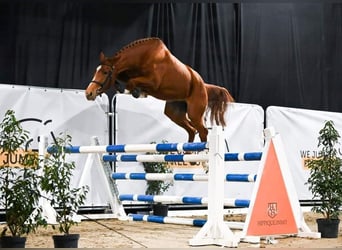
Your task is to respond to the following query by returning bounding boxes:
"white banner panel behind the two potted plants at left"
[0,84,109,206]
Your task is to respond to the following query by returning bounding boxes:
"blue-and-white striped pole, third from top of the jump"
[112,173,256,182]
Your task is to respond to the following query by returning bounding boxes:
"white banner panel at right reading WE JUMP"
[266,106,342,200]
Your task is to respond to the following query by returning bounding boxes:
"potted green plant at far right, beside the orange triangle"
[306,121,342,238]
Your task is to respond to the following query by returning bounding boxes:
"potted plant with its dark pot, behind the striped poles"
[143,140,173,216]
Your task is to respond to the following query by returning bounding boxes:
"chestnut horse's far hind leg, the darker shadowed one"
[164,101,196,142]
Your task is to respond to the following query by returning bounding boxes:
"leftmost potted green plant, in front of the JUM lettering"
[0,110,46,248]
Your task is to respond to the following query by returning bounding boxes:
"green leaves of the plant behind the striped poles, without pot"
[143,141,173,195]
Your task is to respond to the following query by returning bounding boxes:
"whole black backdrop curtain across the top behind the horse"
[0,0,342,112]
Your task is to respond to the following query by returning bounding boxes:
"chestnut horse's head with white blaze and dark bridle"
[85,52,115,100]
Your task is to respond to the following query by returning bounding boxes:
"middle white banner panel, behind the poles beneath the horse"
[113,94,264,202]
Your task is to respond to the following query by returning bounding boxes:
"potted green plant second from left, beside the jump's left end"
[42,134,88,248]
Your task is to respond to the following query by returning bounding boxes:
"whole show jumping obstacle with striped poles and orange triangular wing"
[43,127,319,247]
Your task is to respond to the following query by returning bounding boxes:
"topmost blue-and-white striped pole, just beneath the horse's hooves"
[47,142,208,153]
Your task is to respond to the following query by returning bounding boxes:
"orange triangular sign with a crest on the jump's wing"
[246,140,298,236]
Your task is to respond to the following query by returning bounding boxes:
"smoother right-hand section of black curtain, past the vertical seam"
[238,3,342,112]
